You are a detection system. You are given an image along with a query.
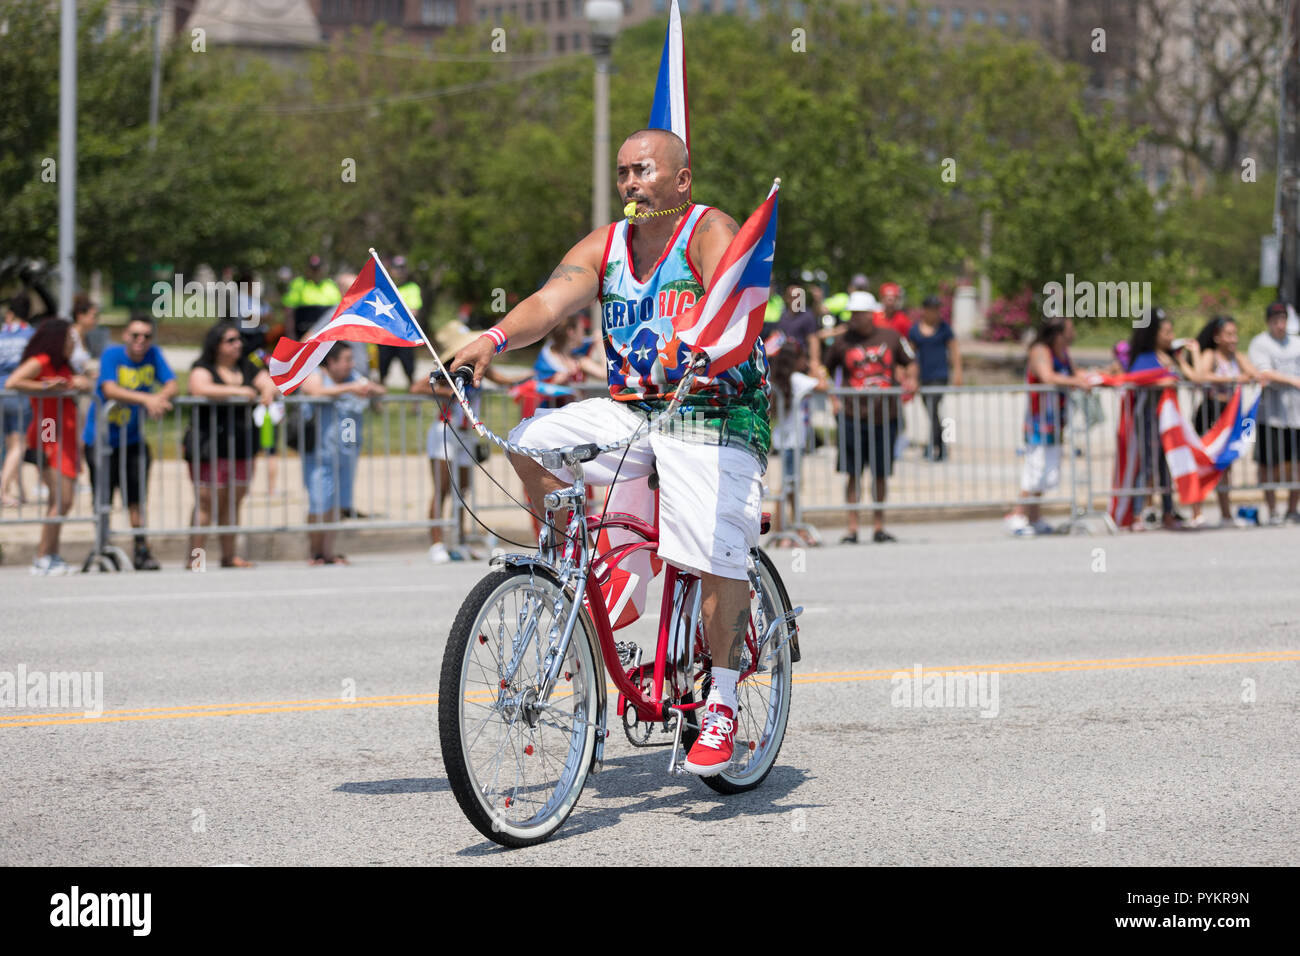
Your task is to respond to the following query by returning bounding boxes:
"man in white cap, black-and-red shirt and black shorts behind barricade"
[826,291,917,544]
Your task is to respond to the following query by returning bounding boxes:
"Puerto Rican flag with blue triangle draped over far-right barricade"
[1160,388,1260,505]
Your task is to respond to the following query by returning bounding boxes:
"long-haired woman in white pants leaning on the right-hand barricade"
[1006,319,1091,537]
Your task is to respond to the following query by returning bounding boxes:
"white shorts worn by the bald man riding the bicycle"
[510,398,763,580]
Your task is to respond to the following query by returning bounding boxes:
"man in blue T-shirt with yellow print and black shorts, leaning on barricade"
[82,312,179,571]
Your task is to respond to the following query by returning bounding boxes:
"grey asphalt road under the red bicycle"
[0,523,1300,865]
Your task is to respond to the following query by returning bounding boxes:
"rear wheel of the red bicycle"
[699,548,794,793]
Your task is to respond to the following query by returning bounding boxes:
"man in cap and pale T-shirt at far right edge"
[1248,302,1300,524]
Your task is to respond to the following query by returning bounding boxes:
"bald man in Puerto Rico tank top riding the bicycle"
[449,130,771,777]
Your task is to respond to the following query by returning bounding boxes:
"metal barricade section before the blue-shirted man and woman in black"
[81,394,470,570]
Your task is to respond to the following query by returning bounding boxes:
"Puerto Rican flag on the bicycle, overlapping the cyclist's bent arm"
[672,179,781,377]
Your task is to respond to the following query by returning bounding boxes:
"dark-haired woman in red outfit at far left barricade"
[4,319,91,575]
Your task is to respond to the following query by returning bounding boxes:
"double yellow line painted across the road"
[0,650,1300,730]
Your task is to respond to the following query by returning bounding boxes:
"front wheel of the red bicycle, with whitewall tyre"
[438,568,601,847]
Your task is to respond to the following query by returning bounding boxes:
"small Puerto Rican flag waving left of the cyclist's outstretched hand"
[269,250,432,395]
